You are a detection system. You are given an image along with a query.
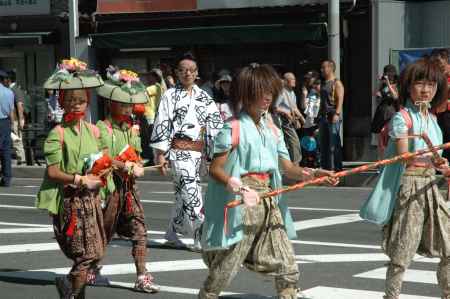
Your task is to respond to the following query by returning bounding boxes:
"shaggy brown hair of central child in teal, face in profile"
[231,63,283,115]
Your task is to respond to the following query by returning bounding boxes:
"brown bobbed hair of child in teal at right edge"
[397,58,448,110]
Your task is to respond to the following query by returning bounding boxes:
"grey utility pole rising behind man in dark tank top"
[328,0,341,78]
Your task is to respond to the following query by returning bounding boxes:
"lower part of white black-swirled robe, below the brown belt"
[169,150,204,236]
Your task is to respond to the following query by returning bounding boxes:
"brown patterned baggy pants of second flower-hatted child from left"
[103,175,147,275]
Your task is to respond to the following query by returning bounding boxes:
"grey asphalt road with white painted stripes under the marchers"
[0,179,440,299]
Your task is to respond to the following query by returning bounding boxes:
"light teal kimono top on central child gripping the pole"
[202,113,297,250]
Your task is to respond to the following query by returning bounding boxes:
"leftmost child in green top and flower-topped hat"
[36,59,106,299]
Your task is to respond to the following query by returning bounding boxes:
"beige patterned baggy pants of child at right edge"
[383,172,450,299]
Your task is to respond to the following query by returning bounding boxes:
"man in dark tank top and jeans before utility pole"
[319,60,344,171]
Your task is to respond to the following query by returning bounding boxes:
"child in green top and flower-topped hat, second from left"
[94,67,159,293]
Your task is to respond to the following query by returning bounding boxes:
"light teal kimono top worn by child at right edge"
[360,100,443,225]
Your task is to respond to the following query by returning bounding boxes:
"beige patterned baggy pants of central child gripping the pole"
[198,178,300,299]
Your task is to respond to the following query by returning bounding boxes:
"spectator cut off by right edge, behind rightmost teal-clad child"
[431,49,450,160]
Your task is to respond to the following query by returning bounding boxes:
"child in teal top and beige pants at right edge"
[362,59,450,299]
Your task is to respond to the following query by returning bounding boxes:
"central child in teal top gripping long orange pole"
[198,64,337,299]
